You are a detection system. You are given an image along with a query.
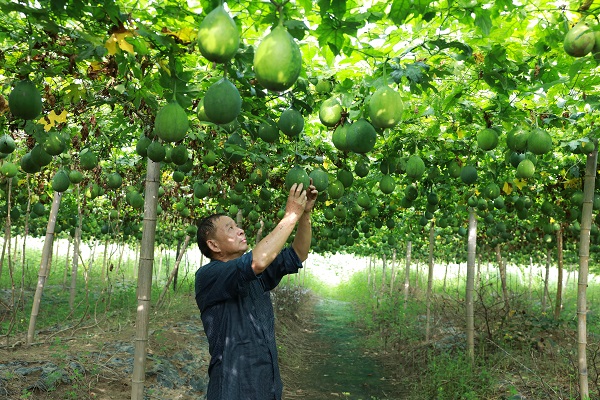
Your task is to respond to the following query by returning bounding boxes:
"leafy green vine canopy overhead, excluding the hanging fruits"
[0,0,600,252]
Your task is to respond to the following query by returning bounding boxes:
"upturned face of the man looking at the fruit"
[209,216,248,261]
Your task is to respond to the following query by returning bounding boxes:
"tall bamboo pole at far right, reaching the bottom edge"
[577,140,598,400]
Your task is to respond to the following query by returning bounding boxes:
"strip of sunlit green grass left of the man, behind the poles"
[0,236,193,341]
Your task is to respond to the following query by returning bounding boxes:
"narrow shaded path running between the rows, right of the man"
[287,299,406,400]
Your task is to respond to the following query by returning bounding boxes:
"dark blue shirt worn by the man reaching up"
[195,247,302,400]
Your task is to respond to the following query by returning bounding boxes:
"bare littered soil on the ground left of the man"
[0,290,209,400]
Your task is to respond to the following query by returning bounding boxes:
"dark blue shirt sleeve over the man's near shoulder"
[195,252,256,312]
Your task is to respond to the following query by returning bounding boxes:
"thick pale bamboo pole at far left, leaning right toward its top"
[27,192,62,346]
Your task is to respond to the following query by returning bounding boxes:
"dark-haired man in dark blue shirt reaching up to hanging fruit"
[195,181,318,400]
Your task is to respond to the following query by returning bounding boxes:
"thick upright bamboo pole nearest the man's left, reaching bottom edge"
[131,159,160,400]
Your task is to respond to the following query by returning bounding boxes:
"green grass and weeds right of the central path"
[310,258,600,400]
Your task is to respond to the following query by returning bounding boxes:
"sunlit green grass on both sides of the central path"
[0,236,600,400]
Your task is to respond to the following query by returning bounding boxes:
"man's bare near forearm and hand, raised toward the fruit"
[252,184,310,274]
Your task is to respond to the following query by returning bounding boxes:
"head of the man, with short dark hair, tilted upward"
[197,214,248,261]
